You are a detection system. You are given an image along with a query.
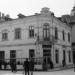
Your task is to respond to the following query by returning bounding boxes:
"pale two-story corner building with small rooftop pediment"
[0,7,72,67]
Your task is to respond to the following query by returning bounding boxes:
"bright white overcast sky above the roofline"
[0,0,75,18]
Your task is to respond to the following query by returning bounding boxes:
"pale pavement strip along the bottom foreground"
[0,69,75,75]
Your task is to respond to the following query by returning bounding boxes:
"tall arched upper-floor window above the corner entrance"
[43,23,50,40]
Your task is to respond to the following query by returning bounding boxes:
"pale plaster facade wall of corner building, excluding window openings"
[0,8,72,69]
